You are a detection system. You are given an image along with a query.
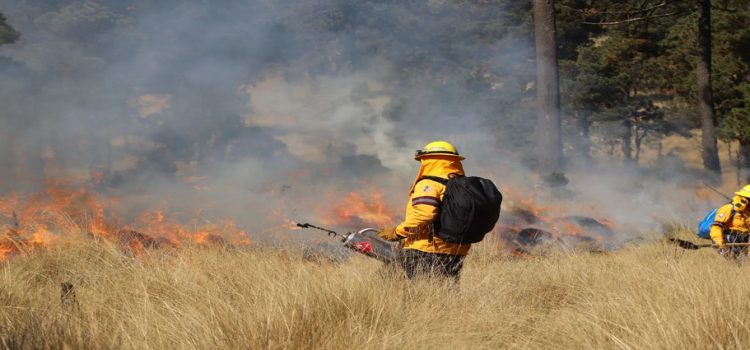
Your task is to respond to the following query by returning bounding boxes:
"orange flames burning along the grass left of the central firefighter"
[0,182,251,261]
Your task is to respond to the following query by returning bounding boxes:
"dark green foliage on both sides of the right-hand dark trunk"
[560,0,750,167]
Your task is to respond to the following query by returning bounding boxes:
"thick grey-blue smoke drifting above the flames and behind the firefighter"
[0,0,716,246]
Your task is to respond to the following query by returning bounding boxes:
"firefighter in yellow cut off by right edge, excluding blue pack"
[711,185,750,258]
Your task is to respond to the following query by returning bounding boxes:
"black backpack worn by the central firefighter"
[419,176,503,243]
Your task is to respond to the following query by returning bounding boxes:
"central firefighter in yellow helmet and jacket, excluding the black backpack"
[378,141,471,279]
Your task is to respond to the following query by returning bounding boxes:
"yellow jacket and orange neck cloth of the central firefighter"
[396,156,471,255]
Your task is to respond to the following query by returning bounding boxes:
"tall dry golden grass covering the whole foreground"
[0,228,750,349]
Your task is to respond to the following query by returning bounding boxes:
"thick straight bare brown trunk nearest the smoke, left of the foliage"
[534,0,563,173]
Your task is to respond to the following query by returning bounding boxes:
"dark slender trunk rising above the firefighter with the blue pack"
[696,0,721,174]
